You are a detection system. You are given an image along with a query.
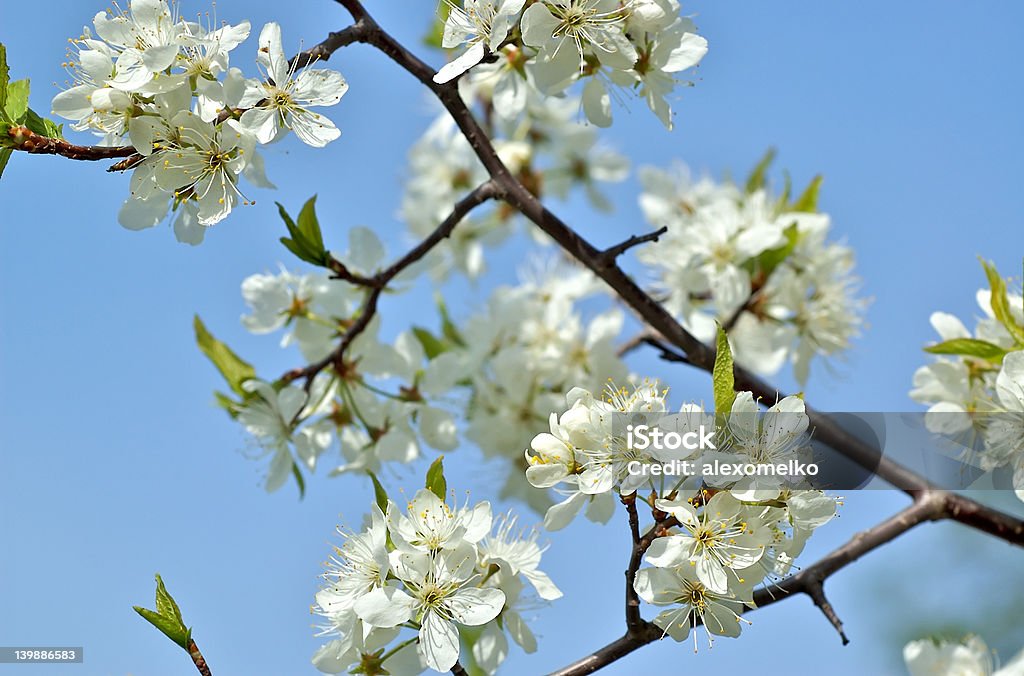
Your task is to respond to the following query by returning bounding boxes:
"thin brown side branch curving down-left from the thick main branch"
[281,180,501,391]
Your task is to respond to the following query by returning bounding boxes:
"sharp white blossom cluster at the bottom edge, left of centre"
[313,489,562,674]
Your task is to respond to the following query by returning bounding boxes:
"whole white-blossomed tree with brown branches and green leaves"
[0,0,1024,675]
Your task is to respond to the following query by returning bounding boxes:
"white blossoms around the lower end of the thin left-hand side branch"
[229,227,458,491]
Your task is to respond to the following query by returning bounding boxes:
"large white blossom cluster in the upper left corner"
[52,0,348,244]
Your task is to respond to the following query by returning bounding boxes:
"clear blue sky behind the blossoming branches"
[0,0,1024,676]
